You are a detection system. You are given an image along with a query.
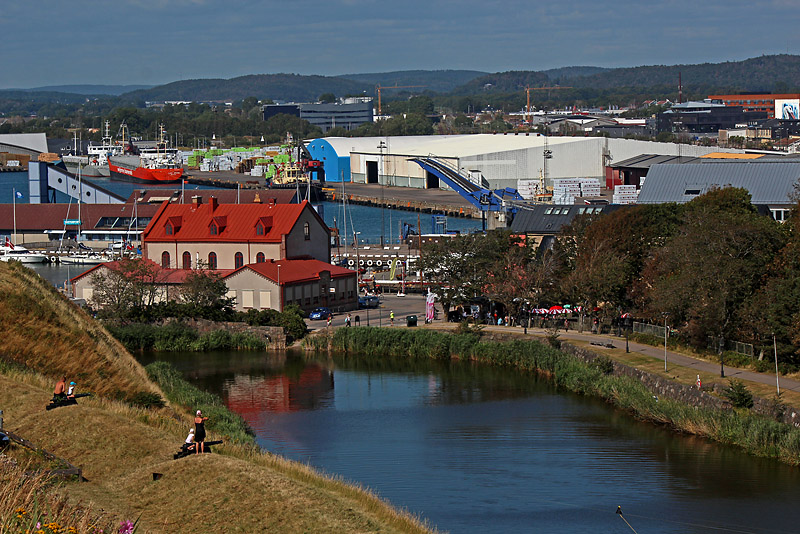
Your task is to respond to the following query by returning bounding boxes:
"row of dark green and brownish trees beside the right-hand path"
[420,188,800,364]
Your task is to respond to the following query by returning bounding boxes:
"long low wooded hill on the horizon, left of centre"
[121,74,375,102]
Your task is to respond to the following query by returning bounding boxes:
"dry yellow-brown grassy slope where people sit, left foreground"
[0,263,427,532]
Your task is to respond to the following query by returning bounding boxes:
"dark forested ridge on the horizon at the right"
[453,54,800,94]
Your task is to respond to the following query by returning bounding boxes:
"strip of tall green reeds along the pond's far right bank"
[320,327,800,465]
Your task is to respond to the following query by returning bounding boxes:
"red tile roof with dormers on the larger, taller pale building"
[142,201,327,243]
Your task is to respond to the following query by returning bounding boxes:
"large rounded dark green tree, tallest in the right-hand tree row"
[643,188,785,347]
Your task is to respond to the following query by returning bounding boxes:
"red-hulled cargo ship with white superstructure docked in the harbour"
[108,124,183,183]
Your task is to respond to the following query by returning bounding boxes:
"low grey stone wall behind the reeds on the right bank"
[561,342,800,427]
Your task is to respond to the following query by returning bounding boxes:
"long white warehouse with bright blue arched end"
[308,133,742,189]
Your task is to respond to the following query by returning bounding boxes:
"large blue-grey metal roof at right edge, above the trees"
[638,160,800,205]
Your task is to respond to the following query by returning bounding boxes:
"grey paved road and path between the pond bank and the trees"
[306,300,800,392]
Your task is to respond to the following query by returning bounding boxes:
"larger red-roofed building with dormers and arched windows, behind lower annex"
[142,197,331,269]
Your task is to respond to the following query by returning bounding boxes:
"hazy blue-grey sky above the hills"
[0,0,800,88]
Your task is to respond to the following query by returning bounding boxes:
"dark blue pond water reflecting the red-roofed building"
[142,352,800,534]
